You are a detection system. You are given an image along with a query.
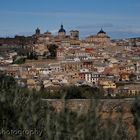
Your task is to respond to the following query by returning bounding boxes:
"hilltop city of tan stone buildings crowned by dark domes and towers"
[0,25,140,97]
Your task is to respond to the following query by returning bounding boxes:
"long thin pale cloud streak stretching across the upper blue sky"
[0,11,139,20]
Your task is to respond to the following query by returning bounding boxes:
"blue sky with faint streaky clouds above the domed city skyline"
[0,0,140,39]
